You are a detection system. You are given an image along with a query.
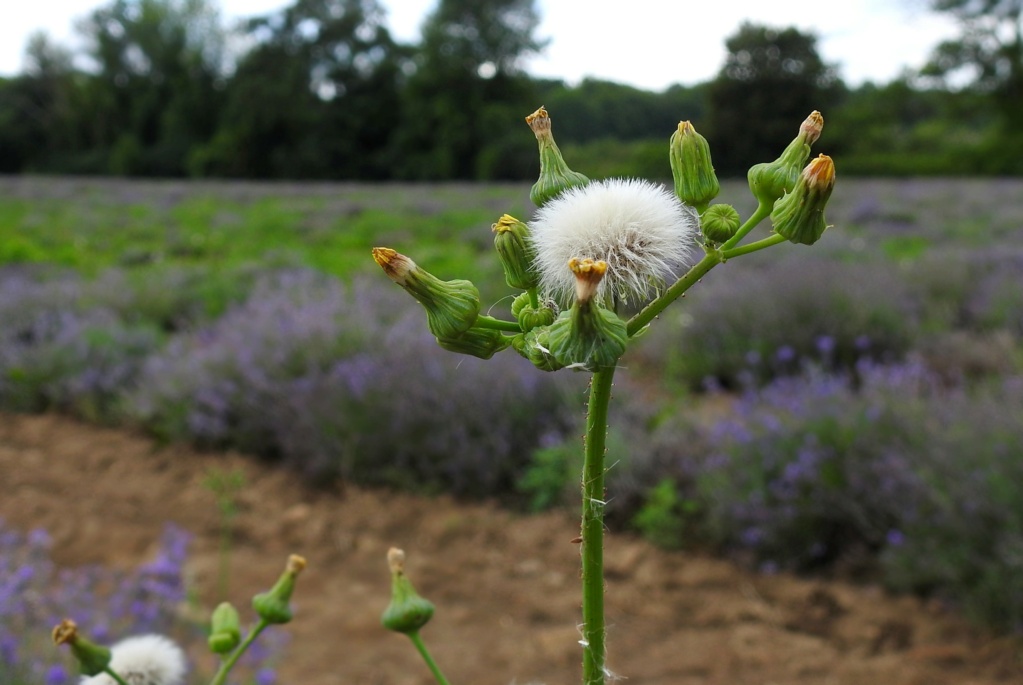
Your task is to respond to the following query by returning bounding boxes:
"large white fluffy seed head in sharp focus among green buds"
[530,179,700,304]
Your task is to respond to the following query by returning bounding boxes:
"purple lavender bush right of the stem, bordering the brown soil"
[589,360,1023,631]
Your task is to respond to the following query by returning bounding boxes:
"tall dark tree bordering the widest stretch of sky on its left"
[394,0,542,179]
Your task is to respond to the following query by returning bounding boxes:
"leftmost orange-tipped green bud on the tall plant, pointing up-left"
[373,247,480,338]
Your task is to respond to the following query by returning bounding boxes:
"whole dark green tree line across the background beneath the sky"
[0,0,1023,181]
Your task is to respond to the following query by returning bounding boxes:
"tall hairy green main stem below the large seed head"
[580,366,615,685]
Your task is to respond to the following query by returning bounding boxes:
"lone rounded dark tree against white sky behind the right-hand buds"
[696,22,842,175]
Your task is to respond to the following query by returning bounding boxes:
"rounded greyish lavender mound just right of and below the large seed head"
[640,255,919,389]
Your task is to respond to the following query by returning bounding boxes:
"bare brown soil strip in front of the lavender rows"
[0,415,1023,685]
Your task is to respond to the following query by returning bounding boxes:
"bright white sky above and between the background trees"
[0,0,955,90]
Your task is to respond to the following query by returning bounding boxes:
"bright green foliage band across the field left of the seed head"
[0,187,519,290]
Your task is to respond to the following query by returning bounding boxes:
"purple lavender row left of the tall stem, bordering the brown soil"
[0,269,578,496]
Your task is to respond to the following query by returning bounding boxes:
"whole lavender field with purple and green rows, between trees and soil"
[0,178,1023,632]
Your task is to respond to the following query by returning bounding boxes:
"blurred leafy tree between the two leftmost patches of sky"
[79,0,226,176]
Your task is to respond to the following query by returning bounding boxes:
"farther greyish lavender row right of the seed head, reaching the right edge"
[638,245,1023,390]
